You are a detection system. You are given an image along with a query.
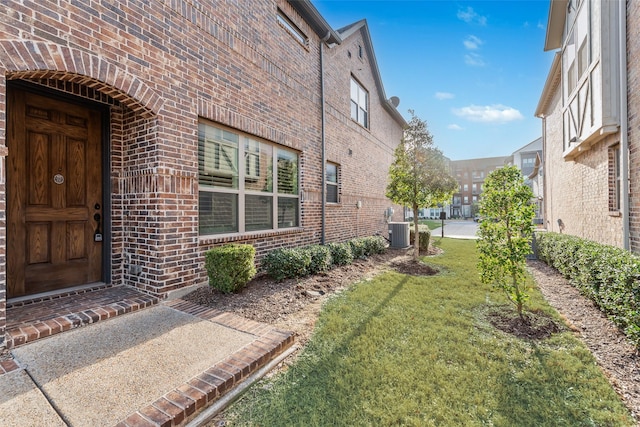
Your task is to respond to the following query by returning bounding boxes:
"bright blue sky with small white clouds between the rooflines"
[312,0,553,160]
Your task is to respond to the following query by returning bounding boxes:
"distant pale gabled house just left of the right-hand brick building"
[511,138,544,224]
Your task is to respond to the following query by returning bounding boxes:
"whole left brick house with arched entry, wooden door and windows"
[0,0,406,347]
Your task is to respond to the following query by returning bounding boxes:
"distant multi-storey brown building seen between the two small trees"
[449,156,512,218]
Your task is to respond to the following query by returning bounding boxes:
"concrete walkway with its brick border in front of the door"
[0,300,293,427]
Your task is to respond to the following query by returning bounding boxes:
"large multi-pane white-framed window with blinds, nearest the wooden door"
[198,119,300,235]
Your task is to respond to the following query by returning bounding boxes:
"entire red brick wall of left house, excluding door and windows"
[0,0,401,320]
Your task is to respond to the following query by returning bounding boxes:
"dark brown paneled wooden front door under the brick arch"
[7,89,103,297]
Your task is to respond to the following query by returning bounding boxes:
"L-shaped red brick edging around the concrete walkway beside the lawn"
[117,299,294,427]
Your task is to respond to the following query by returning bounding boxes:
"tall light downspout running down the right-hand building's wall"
[618,1,631,250]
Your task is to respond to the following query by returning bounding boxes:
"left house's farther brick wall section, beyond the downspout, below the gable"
[325,29,402,241]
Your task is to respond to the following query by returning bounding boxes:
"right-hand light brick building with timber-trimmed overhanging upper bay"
[536,0,624,251]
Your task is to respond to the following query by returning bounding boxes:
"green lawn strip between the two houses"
[222,239,634,426]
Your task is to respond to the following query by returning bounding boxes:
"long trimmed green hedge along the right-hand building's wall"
[536,232,640,347]
